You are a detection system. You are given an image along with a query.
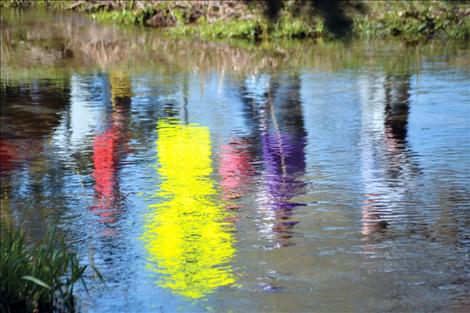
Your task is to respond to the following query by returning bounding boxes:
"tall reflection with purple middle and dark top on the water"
[242,75,306,246]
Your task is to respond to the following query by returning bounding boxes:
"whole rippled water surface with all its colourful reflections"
[0,11,470,312]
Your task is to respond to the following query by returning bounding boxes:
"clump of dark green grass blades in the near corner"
[0,223,102,312]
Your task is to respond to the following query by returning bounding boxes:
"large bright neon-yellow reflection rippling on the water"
[143,120,235,299]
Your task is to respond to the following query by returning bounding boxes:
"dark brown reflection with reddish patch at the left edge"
[0,77,70,226]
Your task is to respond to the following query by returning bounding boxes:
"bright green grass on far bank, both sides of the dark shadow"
[83,0,470,41]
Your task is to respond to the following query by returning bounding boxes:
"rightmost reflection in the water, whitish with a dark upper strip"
[361,75,419,235]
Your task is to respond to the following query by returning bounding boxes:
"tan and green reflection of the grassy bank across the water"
[0,10,470,81]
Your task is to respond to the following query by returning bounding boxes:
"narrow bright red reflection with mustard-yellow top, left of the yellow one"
[91,72,131,223]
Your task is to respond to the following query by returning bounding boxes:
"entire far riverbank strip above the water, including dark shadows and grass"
[2,0,470,41]
